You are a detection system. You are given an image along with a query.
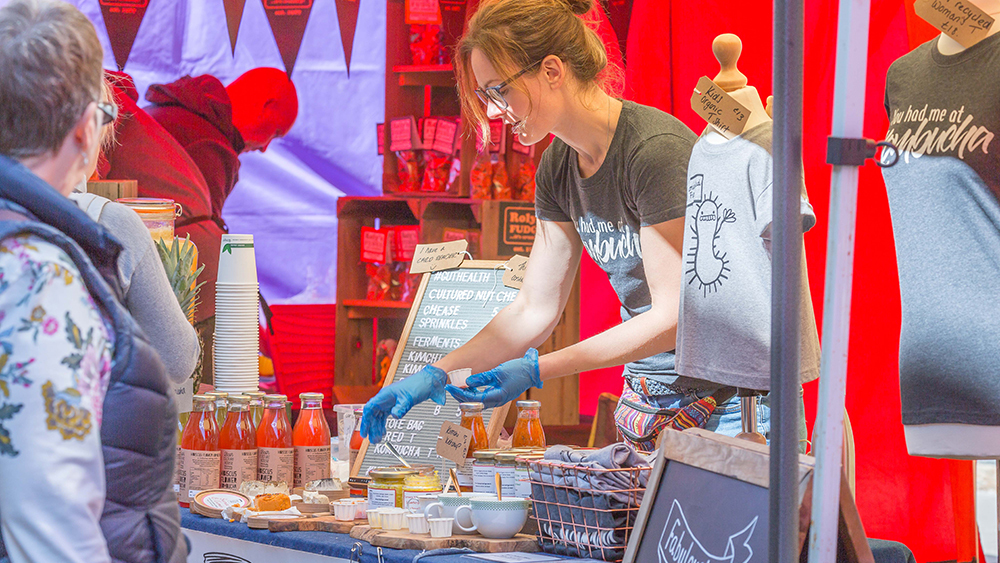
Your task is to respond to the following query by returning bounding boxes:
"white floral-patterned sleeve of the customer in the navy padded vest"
[0,237,114,563]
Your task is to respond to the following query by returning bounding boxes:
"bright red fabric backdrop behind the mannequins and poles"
[580,0,975,562]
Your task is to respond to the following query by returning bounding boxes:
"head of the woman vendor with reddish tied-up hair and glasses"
[455,0,618,148]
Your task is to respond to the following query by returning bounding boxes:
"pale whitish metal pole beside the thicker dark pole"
[809,0,871,563]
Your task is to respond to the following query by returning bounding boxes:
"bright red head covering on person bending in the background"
[226,67,299,152]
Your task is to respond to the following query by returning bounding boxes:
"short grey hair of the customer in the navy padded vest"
[0,0,104,159]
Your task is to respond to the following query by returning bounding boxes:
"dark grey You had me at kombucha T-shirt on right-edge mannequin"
[884,33,1000,426]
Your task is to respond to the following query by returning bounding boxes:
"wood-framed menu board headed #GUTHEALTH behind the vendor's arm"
[351,260,517,475]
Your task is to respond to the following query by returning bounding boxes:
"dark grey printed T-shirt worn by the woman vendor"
[535,101,706,389]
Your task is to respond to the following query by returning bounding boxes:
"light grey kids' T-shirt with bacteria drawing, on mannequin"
[677,121,820,390]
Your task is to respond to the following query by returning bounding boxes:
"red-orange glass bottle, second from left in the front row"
[219,395,257,491]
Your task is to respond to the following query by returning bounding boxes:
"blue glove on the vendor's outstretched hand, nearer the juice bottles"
[361,366,448,444]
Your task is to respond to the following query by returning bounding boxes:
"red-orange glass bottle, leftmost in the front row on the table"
[178,395,220,506]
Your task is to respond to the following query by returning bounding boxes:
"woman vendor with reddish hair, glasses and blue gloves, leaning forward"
[361,0,769,448]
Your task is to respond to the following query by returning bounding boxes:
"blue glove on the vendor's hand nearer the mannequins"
[445,348,542,409]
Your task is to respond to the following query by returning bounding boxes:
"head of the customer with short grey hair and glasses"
[0,0,106,194]
